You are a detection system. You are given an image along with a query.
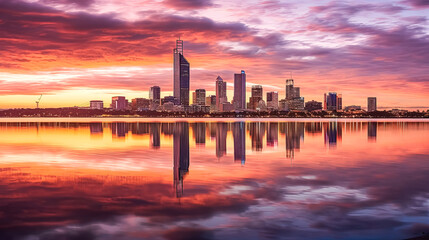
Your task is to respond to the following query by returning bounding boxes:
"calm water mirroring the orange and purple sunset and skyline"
[0,119,429,240]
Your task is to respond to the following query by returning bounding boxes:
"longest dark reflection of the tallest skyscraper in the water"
[173,122,189,198]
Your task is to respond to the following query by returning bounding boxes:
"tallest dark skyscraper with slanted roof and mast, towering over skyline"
[173,39,190,106]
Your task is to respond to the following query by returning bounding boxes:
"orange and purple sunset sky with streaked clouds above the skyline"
[0,0,429,108]
